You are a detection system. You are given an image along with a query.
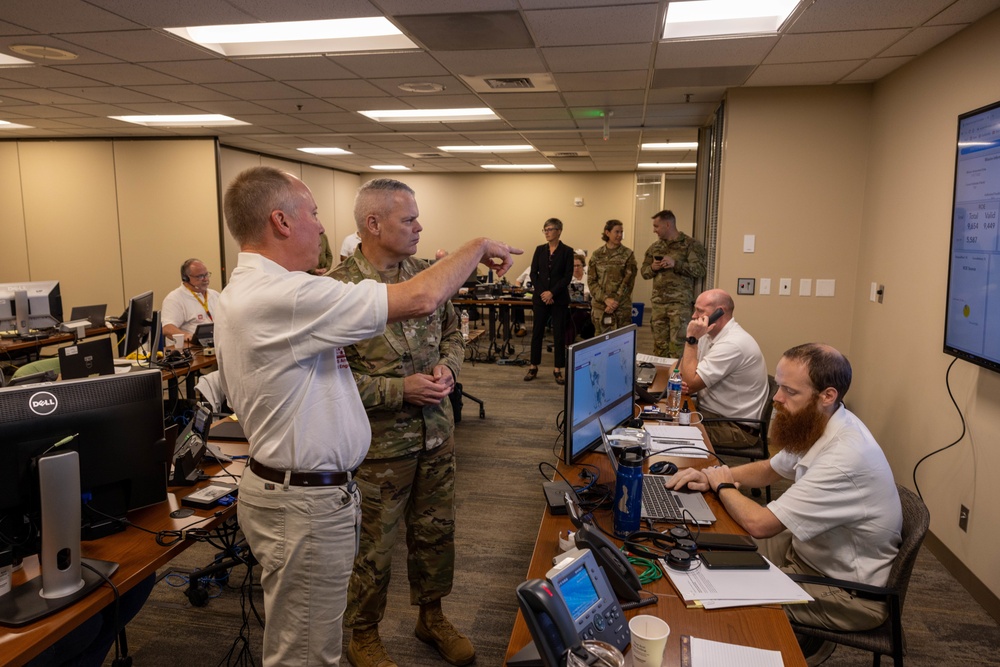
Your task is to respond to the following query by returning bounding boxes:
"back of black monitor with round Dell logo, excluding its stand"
[0,371,171,557]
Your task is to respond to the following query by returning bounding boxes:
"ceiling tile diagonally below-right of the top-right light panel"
[763,29,907,65]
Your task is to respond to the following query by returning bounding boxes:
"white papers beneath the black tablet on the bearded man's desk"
[663,561,813,609]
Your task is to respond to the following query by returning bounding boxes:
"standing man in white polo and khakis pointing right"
[215,167,520,667]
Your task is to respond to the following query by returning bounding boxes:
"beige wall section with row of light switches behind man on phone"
[716,86,871,371]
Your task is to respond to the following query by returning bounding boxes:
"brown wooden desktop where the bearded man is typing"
[504,444,806,667]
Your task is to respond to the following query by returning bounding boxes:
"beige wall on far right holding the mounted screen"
[851,7,1000,595]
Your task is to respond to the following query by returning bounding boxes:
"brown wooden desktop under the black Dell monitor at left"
[0,443,247,665]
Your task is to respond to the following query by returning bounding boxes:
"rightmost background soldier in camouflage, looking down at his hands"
[641,211,705,359]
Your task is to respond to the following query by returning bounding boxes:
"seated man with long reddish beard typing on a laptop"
[668,343,903,664]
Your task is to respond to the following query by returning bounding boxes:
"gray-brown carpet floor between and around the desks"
[105,326,1000,667]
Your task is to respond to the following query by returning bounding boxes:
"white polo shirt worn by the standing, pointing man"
[215,253,388,471]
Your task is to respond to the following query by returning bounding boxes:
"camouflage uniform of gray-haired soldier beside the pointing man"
[330,252,465,629]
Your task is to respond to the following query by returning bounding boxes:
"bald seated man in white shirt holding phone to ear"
[677,289,768,447]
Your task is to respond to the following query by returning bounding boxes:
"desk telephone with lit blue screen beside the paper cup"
[507,549,632,667]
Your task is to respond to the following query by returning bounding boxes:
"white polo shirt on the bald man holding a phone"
[695,320,767,419]
